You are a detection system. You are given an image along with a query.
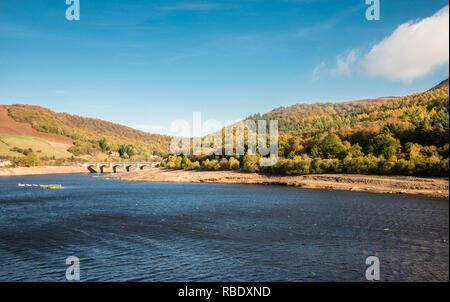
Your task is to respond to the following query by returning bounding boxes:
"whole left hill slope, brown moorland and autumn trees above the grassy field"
[0,105,171,160]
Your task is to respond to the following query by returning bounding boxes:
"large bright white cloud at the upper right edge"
[362,5,449,82]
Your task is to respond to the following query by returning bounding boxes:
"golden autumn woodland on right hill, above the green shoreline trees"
[250,79,449,162]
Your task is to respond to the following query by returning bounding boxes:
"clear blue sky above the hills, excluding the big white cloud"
[0,0,449,133]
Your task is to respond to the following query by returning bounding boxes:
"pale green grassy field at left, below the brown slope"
[0,134,72,158]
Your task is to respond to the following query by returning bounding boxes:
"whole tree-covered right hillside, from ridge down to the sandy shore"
[162,80,449,176]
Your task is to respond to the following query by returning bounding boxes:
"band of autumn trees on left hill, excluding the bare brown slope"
[6,105,171,158]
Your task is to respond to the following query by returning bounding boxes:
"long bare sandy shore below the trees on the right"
[108,168,449,198]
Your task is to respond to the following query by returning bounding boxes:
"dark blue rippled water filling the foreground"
[0,175,449,281]
